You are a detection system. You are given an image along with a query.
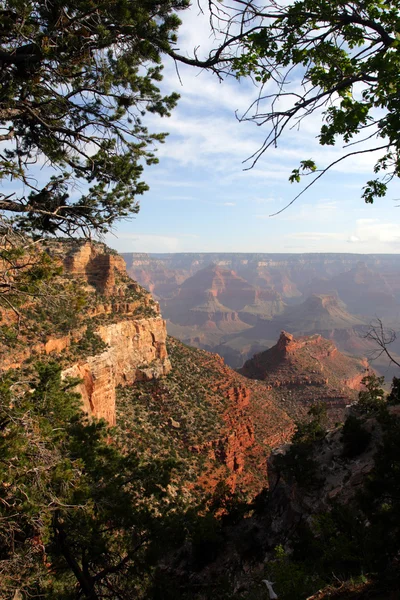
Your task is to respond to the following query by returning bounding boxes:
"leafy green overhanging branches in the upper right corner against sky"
[171,0,400,211]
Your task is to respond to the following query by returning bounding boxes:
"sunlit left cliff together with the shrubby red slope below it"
[0,242,294,497]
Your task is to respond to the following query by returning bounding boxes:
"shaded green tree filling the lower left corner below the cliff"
[0,363,182,600]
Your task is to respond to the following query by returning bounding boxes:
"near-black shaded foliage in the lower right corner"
[258,376,400,600]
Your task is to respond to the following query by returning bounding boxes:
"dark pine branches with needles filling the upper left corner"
[0,0,188,235]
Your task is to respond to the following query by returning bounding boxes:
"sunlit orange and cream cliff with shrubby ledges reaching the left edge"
[0,242,171,425]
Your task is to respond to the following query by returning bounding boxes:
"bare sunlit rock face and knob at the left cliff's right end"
[59,242,171,424]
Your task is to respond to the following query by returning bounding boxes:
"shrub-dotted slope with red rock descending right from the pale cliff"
[117,338,294,498]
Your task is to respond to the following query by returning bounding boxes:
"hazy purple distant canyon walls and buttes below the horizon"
[122,253,400,379]
